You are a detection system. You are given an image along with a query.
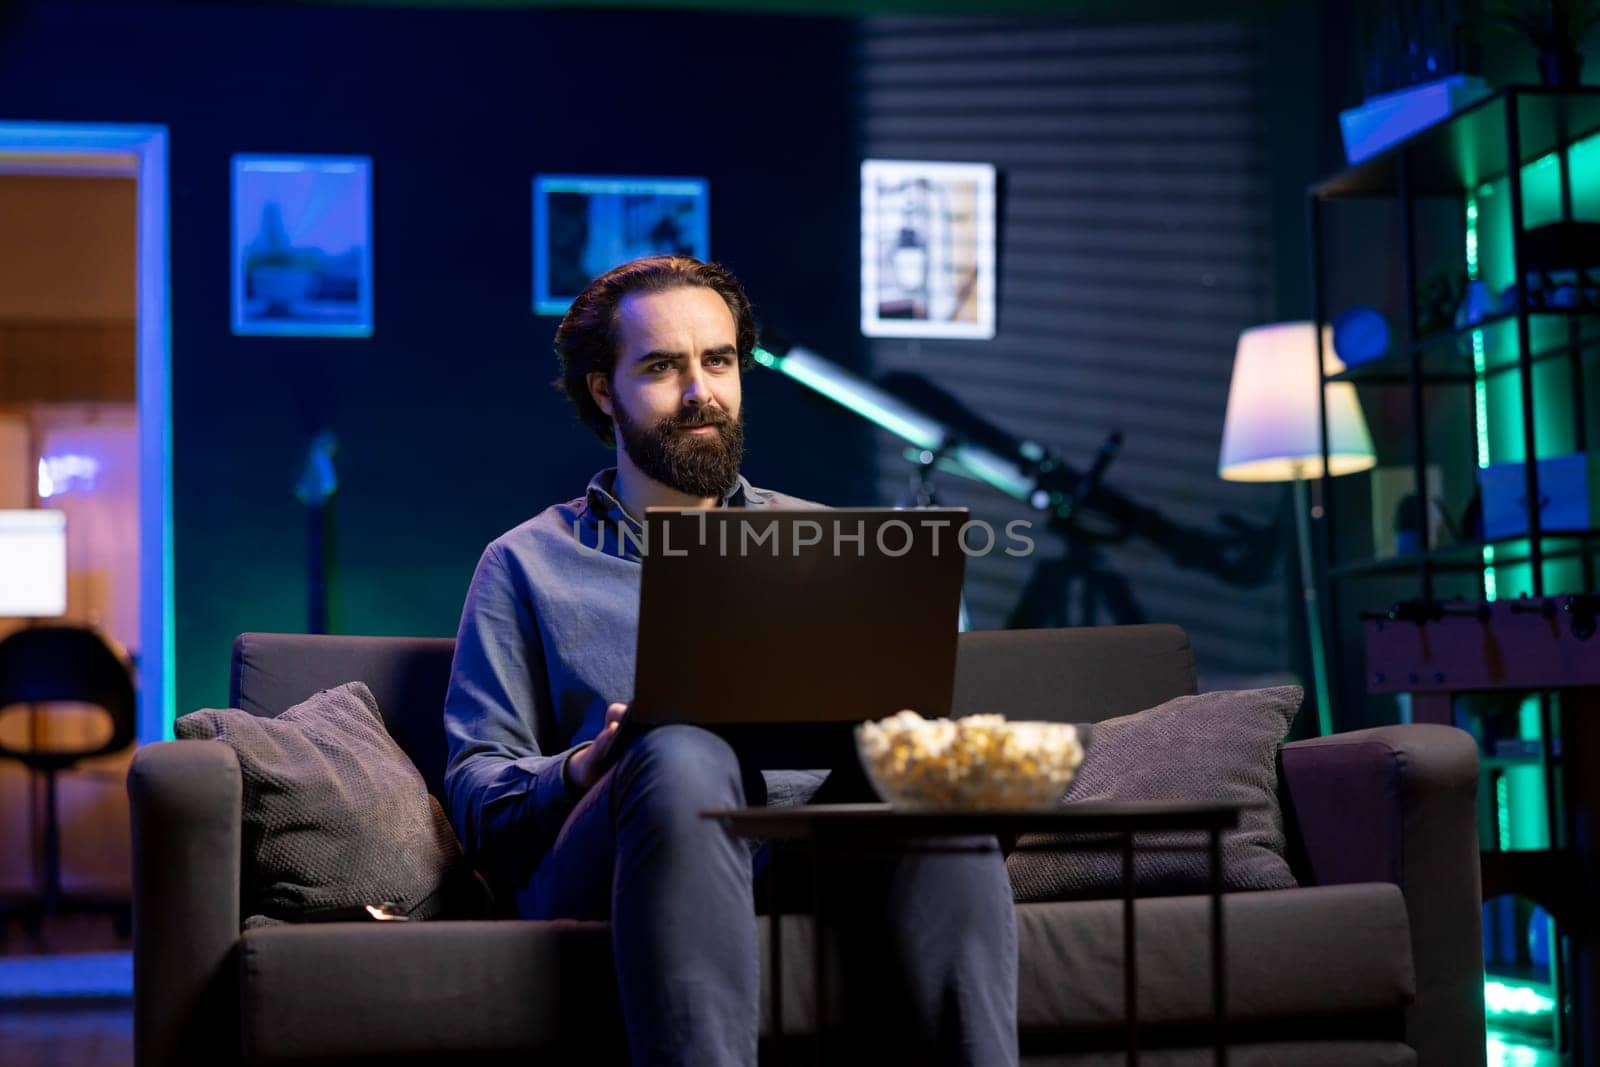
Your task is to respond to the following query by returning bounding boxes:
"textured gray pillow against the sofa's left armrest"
[176,681,461,925]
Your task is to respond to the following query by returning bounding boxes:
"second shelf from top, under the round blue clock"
[1328,309,1600,386]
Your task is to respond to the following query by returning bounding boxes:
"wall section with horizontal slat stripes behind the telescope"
[859,18,1293,683]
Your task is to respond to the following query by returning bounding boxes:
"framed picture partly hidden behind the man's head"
[533,174,710,315]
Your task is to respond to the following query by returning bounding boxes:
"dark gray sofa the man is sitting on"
[128,625,1485,1067]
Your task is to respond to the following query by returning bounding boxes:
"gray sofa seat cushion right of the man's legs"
[1016,883,1416,1037]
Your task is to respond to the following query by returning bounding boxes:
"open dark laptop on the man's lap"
[629,507,968,768]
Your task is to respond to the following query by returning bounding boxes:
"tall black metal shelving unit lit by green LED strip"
[1309,88,1600,1056]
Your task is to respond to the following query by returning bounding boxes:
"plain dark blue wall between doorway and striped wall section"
[0,3,872,713]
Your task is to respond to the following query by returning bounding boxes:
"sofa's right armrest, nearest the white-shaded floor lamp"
[1282,725,1485,1067]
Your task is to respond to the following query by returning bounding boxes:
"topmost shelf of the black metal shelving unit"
[1310,86,1600,200]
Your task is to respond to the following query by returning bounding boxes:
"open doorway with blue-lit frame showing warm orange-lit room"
[0,122,173,966]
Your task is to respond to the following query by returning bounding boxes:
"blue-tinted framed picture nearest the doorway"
[234,155,373,338]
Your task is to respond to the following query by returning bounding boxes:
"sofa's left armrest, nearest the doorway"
[128,741,243,1067]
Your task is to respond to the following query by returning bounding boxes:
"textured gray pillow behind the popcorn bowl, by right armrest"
[1006,685,1304,901]
